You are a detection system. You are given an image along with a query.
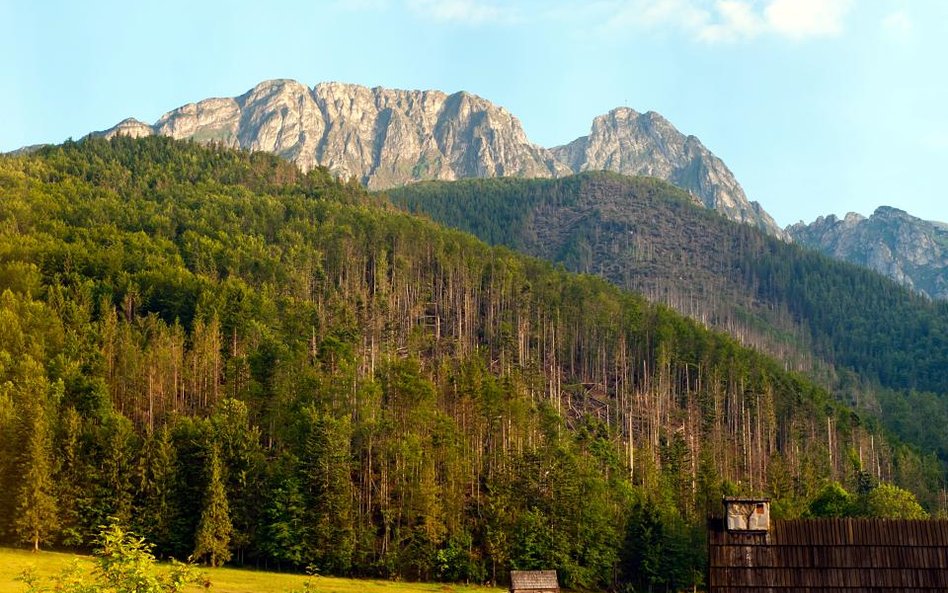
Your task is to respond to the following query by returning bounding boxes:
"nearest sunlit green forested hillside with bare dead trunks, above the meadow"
[0,138,941,589]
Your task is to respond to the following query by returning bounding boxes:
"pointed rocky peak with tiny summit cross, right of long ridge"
[552,107,786,238]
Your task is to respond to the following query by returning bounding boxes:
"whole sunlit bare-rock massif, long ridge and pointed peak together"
[99,80,786,238]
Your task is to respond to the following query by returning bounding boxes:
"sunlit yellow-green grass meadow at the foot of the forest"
[0,548,503,593]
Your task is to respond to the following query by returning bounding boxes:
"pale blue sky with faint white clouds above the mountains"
[0,0,948,225]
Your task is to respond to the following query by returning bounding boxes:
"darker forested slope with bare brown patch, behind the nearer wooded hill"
[390,173,948,476]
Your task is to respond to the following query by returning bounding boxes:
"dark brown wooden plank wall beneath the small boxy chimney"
[708,519,948,593]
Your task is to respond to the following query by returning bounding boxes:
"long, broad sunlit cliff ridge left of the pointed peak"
[103,80,569,189]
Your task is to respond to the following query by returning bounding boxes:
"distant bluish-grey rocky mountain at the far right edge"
[787,206,948,299]
